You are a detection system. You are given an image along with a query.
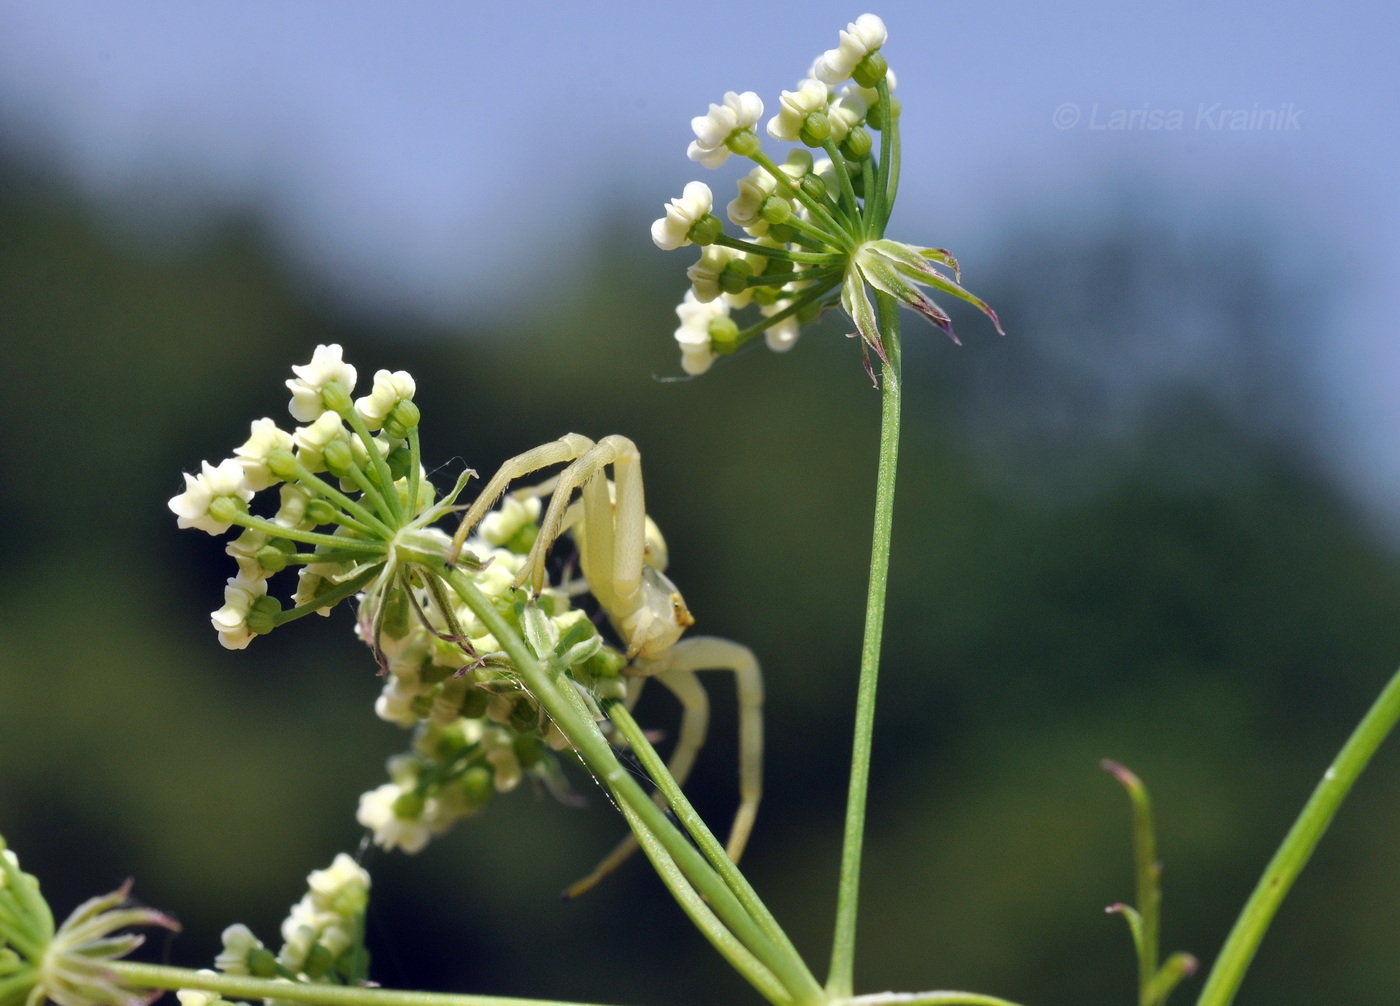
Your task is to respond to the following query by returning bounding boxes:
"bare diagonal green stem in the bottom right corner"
[1196,660,1400,1006]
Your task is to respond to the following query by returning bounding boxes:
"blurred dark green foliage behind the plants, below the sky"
[0,149,1400,1006]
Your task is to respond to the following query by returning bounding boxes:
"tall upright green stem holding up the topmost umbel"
[826,292,903,996]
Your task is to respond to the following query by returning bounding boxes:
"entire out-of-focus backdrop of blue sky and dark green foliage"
[0,0,1400,1006]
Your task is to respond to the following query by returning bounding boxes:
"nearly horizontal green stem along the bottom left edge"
[105,961,618,1006]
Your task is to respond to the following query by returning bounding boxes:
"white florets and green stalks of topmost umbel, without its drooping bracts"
[651,14,895,375]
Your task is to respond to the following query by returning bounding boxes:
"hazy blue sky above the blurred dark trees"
[0,0,1400,513]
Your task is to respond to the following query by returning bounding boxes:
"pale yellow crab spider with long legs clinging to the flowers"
[448,434,763,895]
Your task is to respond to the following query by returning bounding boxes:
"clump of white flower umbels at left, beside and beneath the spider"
[170,346,626,856]
